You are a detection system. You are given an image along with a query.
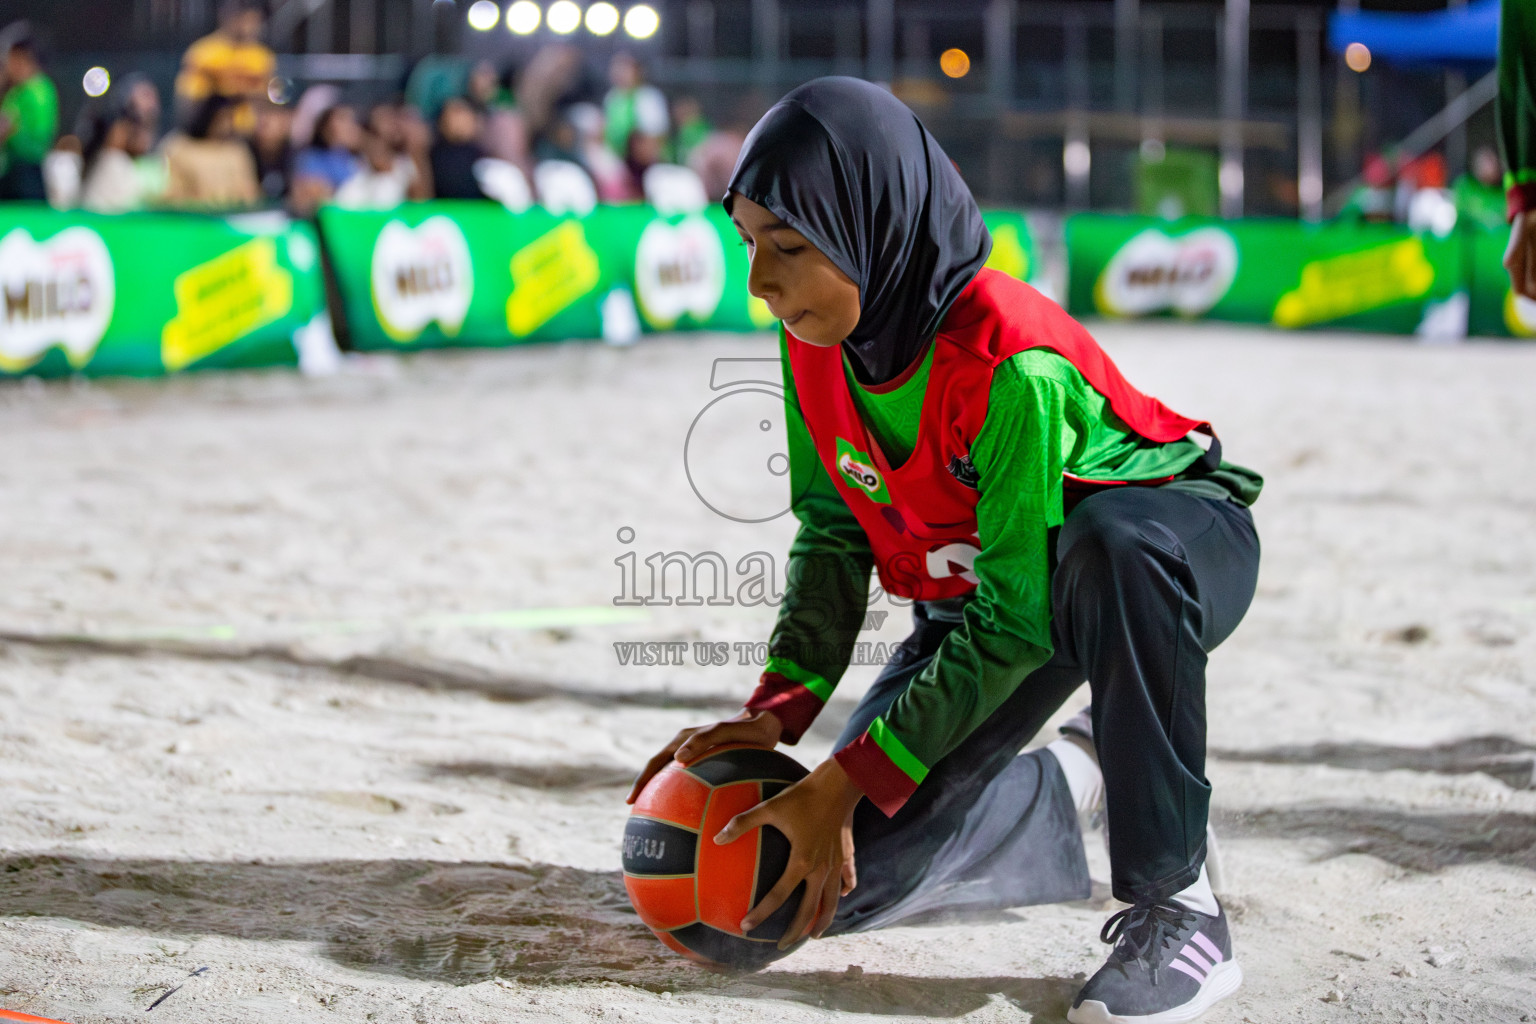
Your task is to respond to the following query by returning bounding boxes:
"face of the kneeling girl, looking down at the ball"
[731,193,860,348]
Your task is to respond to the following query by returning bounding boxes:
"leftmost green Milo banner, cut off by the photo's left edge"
[0,204,323,376]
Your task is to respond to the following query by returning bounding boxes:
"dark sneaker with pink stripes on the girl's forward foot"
[1066,901,1243,1024]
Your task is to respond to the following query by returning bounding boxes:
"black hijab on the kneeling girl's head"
[725,77,992,384]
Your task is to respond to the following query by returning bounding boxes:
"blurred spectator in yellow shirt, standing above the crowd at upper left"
[177,0,276,135]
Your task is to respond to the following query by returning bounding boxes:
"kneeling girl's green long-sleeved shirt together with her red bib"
[746,270,1263,814]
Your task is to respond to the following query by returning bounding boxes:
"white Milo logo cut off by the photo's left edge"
[0,227,117,373]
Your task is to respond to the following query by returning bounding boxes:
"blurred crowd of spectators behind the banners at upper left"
[0,0,742,216]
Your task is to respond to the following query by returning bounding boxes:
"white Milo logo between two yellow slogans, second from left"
[370,216,475,342]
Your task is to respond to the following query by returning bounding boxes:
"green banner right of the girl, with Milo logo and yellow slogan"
[1066,213,1465,335]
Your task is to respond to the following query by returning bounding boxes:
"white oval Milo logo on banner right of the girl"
[1094,227,1238,316]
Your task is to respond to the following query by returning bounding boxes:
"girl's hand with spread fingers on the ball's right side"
[714,758,863,949]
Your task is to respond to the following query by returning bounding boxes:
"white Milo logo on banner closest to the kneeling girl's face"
[634,215,725,329]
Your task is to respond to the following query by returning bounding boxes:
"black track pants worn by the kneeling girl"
[829,487,1258,933]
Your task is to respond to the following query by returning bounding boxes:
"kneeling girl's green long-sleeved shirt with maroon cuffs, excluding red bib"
[746,328,1263,814]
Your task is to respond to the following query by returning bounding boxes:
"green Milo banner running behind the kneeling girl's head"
[319,201,1037,350]
